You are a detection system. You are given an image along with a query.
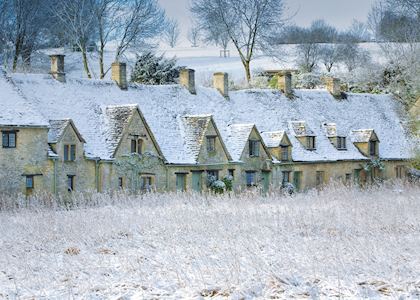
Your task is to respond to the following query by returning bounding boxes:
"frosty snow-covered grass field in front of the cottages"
[0,185,420,299]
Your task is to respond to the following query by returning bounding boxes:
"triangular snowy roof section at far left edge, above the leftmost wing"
[0,68,48,127]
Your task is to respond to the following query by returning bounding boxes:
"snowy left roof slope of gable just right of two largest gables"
[226,124,255,161]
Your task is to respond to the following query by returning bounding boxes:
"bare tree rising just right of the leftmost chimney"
[52,0,96,78]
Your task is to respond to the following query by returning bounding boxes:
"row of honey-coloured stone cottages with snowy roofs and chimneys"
[0,55,411,194]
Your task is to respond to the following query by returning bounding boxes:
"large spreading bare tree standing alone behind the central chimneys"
[191,0,284,82]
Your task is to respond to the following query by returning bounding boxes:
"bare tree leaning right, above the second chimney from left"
[115,0,167,61]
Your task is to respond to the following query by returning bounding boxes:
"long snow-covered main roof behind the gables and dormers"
[12,74,411,163]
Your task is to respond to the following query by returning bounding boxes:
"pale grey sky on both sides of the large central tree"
[159,0,375,36]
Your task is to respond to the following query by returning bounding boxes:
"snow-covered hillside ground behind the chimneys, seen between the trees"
[28,43,384,85]
